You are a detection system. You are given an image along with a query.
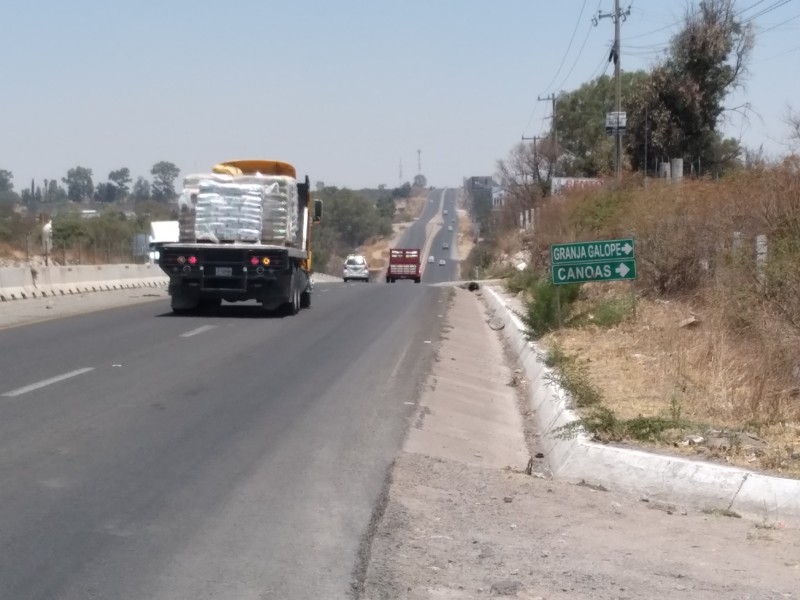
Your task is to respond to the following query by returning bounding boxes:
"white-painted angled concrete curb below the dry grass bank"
[481,287,800,523]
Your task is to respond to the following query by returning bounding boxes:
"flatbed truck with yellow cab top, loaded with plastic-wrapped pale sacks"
[159,160,322,315]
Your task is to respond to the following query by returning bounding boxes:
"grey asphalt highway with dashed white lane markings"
[0,190,455,600]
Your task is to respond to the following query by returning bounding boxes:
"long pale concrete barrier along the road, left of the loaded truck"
[0,265,169,301]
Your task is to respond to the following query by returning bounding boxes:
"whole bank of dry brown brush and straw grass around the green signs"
[512,163,800,476]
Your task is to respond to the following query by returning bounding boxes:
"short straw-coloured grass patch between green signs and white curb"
[542,284,800,477]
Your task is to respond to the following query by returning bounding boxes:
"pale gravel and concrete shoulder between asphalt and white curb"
[359,290,800,600]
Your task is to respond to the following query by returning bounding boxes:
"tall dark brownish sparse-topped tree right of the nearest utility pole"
[627,0,754,172]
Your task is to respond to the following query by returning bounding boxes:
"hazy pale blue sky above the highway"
[0,0,800,190]
